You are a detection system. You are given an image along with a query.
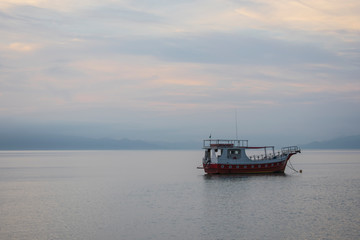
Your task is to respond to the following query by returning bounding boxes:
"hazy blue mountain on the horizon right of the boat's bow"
[301,135,360,149]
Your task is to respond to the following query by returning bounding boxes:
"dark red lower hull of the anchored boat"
[203,154,293,174]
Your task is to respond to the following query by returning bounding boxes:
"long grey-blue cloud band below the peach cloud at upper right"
[93,32,341,65]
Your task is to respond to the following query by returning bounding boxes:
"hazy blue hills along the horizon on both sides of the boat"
[0,130,360,150]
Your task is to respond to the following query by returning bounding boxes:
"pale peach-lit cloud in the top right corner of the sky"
[235,0,360,31]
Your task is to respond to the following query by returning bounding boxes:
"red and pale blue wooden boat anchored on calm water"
[202,139,301,174]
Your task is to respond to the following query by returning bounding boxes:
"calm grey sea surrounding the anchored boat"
[0,149,360,240]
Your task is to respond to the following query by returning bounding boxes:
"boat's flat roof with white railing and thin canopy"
[203,139,274,149]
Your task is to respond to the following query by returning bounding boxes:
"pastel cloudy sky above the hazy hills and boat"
[0,0,360,144]
